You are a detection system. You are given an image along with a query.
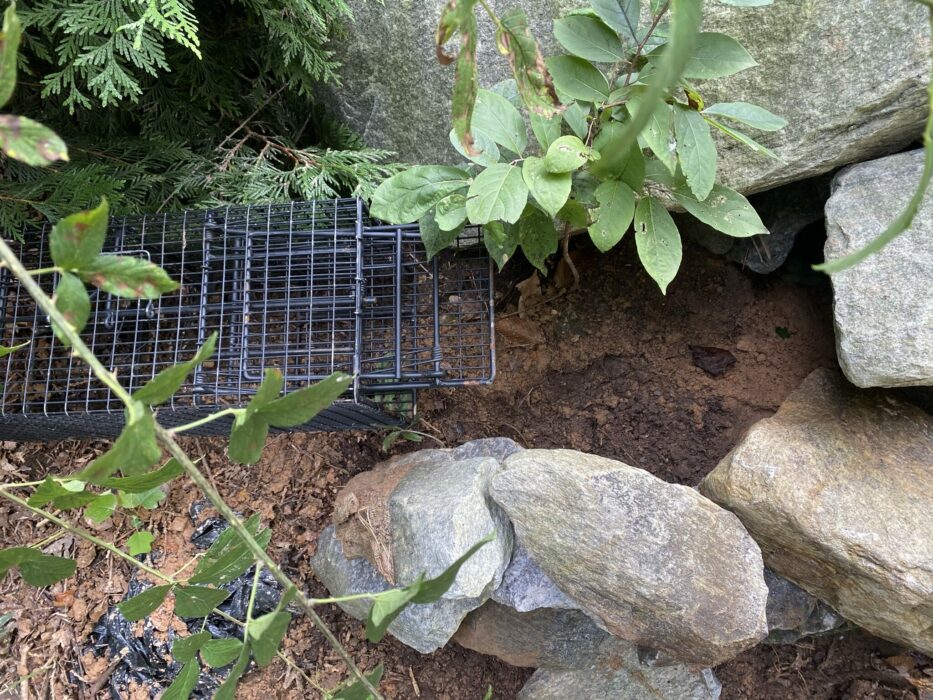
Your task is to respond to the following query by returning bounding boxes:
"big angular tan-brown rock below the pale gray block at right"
[701,370,933,654]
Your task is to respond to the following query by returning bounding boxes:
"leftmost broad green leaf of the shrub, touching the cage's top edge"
[369,165,470,224]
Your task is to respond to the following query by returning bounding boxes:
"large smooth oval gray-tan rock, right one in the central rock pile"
[490,450,768,666]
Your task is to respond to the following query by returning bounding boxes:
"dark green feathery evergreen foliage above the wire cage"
[0,0,396,233]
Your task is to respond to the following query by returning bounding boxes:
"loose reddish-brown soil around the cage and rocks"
[0,241,928,700]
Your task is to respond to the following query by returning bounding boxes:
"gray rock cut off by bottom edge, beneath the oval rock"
[518,651,722,700]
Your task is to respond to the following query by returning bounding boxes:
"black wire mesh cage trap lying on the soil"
[0,199,495,440]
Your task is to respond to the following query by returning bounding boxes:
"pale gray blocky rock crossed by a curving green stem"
[825,151,933,387]
